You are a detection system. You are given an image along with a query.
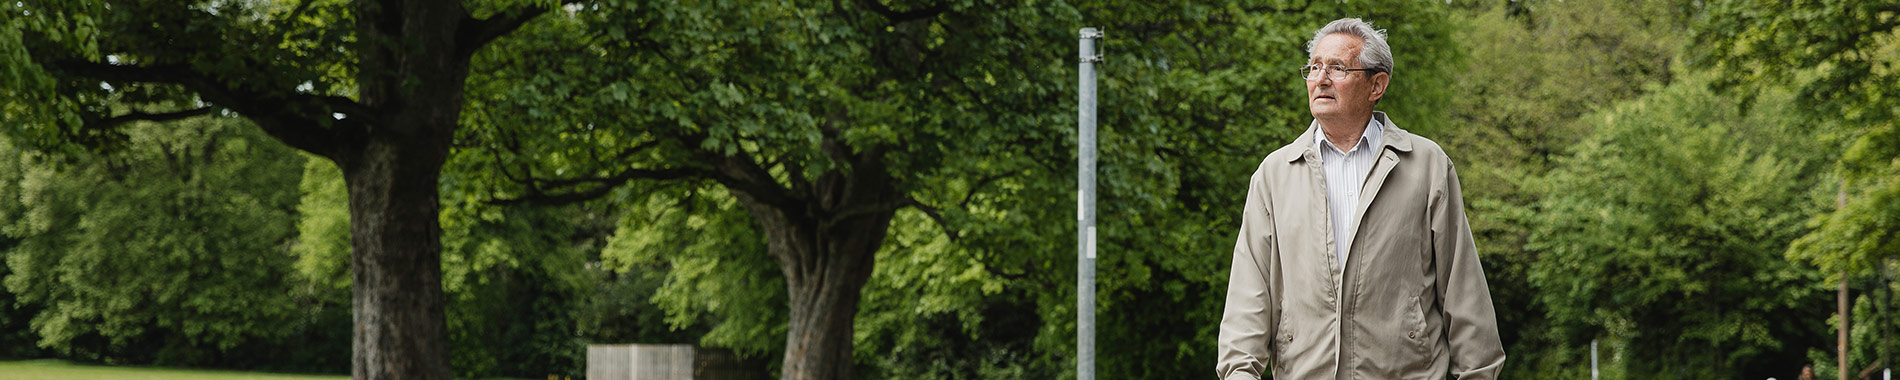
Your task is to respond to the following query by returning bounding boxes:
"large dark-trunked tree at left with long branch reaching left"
[0,0,573,378]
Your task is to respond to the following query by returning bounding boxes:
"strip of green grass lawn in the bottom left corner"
[0,361,350,380]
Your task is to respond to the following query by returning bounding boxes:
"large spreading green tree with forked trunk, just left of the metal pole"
[454,2,1074,378]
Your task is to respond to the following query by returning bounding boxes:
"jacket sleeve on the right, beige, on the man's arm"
[1431,160,1505,380]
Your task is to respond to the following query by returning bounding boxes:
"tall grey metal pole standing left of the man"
[1075,29,1102,380]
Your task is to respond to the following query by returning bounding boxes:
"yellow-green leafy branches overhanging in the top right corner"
[1697,0,1900,281]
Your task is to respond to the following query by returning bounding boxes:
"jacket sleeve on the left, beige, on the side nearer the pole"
[1214,173,1281,380]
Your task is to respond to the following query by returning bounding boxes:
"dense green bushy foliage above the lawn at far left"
[0,118,300,365]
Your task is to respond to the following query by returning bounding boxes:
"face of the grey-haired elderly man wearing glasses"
[1307,32,1389,120]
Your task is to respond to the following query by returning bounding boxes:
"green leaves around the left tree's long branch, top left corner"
[0,0,353,160]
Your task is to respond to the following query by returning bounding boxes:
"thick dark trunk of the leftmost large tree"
[331,0,467,380]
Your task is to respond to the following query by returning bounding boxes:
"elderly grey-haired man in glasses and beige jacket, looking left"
[1216,19,1505,380]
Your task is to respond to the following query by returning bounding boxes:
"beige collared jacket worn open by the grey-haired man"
[1216,112,1505,380]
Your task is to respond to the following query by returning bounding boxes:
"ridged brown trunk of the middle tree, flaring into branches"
[733,154,903,380]
